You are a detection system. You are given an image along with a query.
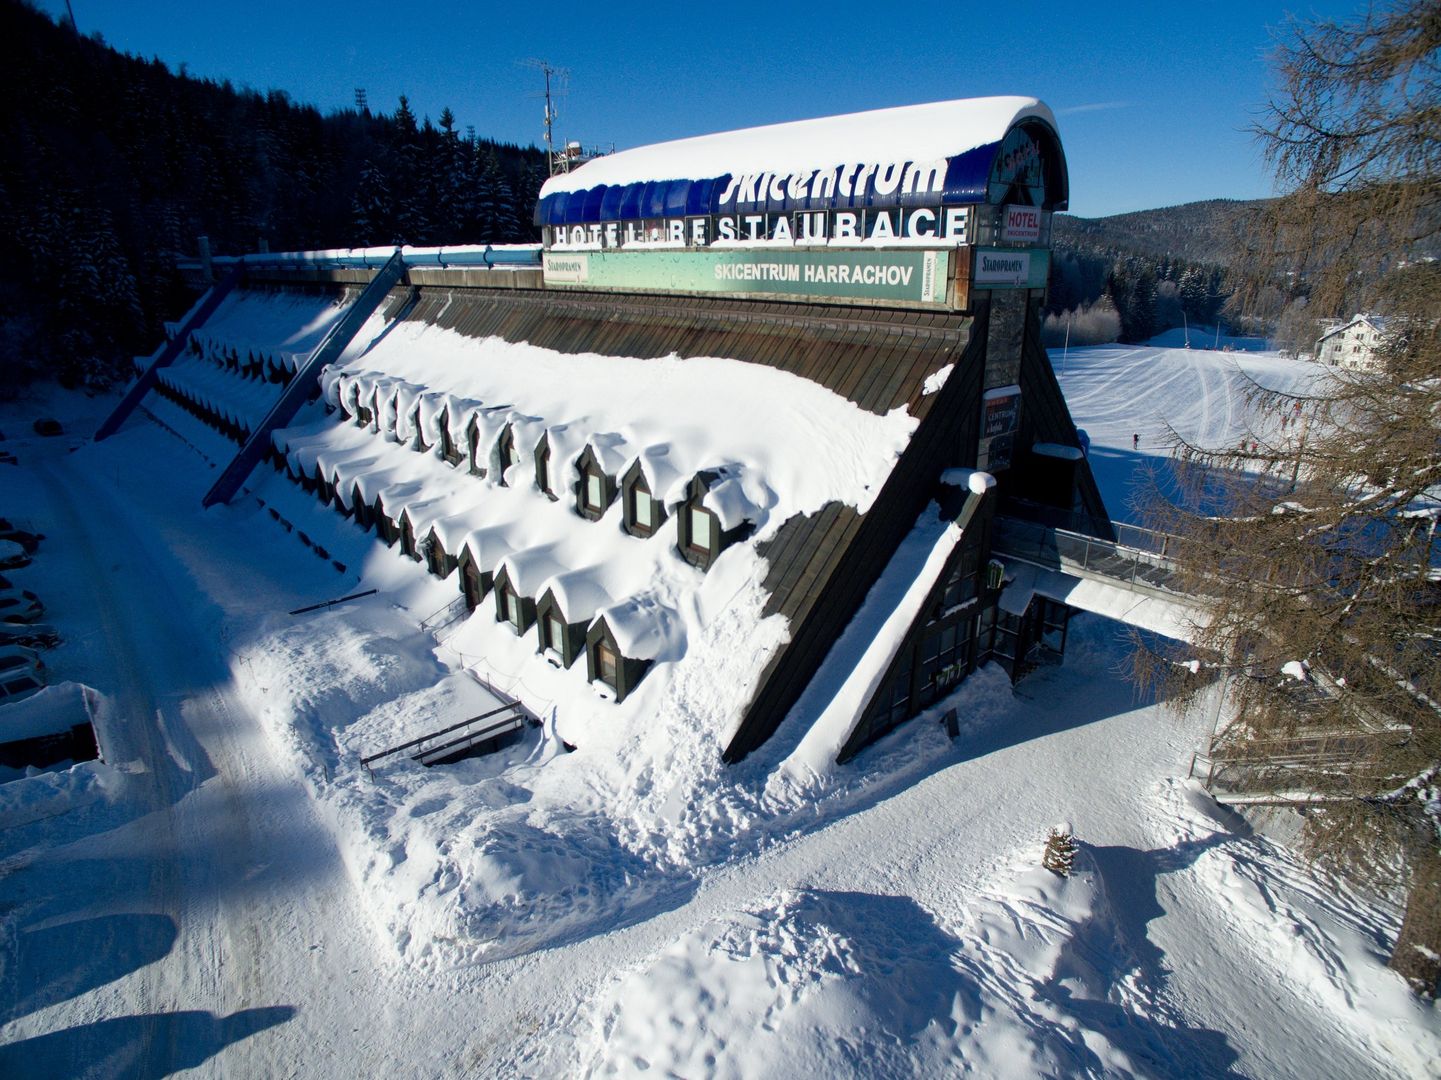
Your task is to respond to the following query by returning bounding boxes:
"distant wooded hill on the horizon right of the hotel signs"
[1050,199,1267,267]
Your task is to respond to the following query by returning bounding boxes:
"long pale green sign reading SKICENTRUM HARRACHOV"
[542,248,951,307]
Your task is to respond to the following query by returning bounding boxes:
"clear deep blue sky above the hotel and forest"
[30,0,1360,216]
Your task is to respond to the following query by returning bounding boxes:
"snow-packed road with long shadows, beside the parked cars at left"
[0,441,417,1076]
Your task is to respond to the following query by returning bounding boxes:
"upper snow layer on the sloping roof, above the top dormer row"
[333,323,916,539]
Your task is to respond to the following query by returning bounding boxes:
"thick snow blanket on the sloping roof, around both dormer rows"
[207,286,918,769]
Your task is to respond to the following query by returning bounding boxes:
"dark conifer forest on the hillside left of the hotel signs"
[0,0,545,394]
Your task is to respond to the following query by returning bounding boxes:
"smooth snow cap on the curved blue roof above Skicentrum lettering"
[540,97,1056,198]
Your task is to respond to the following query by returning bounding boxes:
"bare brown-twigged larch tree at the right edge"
[1143,0,1441,996]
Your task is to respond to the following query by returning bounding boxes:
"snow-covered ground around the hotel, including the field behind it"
[0,348,1441,1077]
